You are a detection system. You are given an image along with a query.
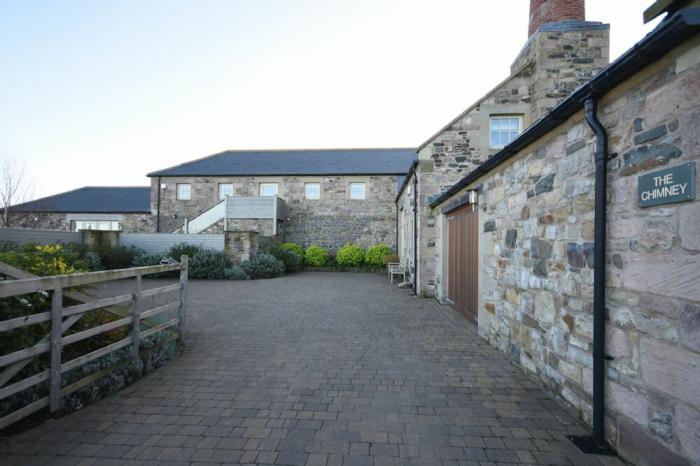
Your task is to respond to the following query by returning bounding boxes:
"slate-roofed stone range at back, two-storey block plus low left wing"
[10,148,416,250]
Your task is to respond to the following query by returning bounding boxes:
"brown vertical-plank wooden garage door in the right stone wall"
[447,205,479,322]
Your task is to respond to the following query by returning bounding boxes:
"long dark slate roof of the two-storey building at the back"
[148,148,416,176]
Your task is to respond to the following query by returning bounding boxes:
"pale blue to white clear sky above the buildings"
[0,0,656,198]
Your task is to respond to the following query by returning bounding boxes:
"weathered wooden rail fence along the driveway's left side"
[0,256,188,429]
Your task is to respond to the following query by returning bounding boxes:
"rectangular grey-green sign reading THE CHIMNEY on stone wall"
[637,162,695,207]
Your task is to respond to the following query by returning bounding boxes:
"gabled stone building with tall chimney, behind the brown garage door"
[396,0,609,296]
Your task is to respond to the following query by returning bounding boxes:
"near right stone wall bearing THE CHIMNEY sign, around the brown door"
[435,38,700,465]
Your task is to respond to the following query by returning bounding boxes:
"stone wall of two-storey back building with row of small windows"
[156,176,397,250]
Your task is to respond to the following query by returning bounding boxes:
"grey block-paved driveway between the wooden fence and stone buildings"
[0,273,619,466]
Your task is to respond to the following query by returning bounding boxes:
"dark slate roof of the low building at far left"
[10,186,151,214]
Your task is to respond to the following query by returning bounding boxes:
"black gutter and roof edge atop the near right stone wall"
[430,8,700,209]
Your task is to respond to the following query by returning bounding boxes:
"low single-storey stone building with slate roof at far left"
[9,186,154,232]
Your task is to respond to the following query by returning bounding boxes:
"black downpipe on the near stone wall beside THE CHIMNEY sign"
[585,96,608,449]
